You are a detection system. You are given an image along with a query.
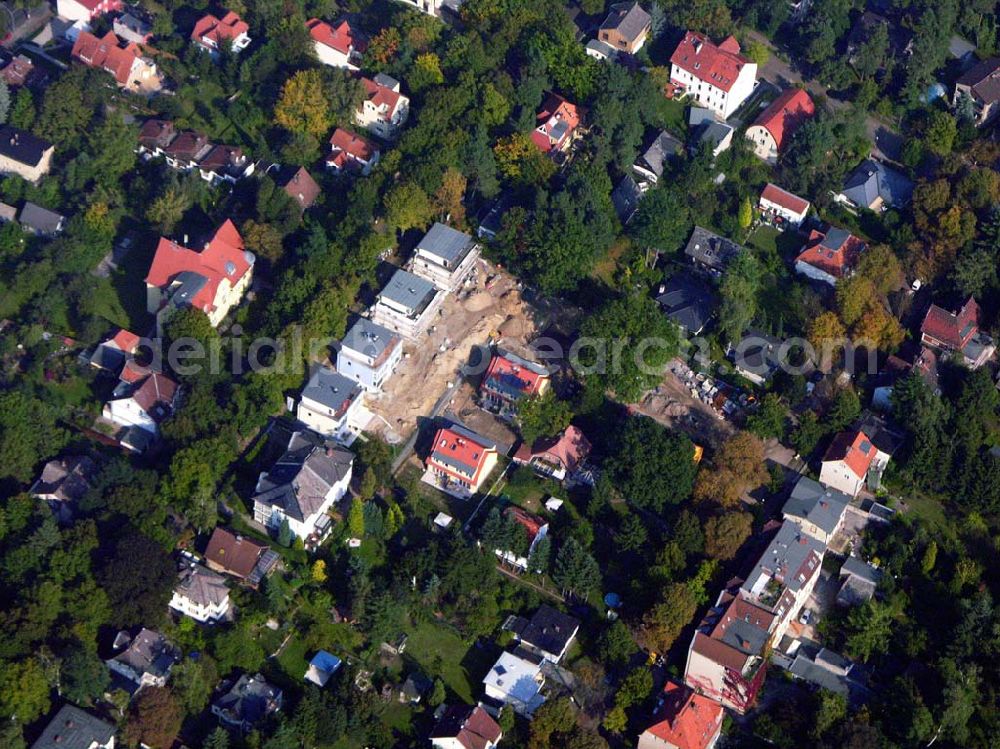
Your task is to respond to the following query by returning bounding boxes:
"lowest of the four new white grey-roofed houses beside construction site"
[295,366,371,446]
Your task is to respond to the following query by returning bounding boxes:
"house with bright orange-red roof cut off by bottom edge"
[636,681,725,749]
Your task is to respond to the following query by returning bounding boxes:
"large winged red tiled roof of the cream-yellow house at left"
[146,219,253,314]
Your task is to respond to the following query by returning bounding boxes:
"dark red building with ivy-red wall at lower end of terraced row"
[684,589,776,714]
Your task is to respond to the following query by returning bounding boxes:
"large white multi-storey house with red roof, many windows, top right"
[670,31,757,120]
